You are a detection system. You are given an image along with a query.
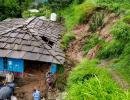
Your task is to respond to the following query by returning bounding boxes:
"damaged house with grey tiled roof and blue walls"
[0,17,65,76]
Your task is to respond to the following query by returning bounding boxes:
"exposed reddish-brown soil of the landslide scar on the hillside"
[66,13,119,62]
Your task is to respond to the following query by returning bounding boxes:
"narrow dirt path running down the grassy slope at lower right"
[100,60,130,90]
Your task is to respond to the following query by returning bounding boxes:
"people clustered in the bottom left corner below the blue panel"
[0,72,17,100]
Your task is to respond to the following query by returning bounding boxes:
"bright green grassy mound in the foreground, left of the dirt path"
[66,59,128,100]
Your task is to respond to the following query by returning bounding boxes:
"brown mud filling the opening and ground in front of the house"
[15,64,48,100]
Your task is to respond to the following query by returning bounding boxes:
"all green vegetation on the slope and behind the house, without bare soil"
[0,0,130,100]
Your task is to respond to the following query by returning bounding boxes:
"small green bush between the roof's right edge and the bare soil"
[61,32,75,49]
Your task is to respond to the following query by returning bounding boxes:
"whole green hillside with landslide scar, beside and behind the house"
[0,0,130,100]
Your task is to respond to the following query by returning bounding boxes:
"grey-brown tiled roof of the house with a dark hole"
[0,18,65,64]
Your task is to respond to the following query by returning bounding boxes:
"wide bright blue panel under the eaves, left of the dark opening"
[7,58,24,73]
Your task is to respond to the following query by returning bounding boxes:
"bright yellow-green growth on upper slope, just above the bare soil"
[62,0,96,30]
